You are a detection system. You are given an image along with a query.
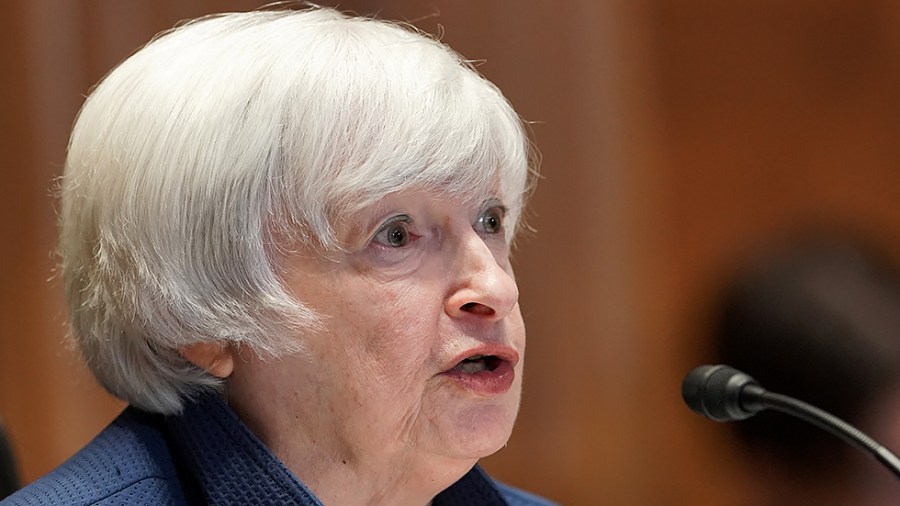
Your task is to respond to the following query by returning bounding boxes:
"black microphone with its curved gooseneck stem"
[681,365,900,478]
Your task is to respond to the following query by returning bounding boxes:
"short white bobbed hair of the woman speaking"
[59,8,532,413]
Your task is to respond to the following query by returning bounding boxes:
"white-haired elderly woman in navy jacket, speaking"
[4,9,549,506]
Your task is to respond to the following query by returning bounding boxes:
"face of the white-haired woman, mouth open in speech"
[236,191,525,478]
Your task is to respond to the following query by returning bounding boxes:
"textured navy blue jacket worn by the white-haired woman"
[0,395,552,506]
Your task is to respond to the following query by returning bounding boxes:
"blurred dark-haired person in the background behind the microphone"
[713,231,900,506]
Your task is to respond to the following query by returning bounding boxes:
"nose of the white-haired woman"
[446,232,519,320]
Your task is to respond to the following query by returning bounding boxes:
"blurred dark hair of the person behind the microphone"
[713,235,900,477]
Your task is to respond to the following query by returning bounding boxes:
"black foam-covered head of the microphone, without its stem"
[681,365,764,422]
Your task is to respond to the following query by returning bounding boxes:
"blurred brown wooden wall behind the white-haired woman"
[0,0,900,505]
